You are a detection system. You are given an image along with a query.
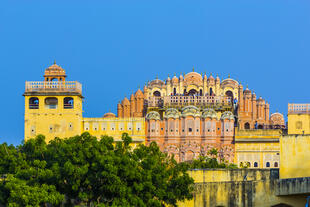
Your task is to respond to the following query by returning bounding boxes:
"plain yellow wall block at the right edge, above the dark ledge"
[280,135,310,179]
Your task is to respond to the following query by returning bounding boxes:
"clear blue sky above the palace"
[0,0,310,144]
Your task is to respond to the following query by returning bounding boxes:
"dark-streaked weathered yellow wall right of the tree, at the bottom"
[178,169,307,207]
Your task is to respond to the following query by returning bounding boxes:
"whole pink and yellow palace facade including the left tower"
[24,63,285,167]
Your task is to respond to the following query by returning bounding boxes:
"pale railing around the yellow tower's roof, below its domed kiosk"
[25,81,82,94]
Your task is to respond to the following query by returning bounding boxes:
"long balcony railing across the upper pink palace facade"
[145,95,233,108]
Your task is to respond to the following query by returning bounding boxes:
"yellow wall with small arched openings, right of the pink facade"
[235,128,281,168]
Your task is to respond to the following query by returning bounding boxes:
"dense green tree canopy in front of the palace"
[0,132,193,206]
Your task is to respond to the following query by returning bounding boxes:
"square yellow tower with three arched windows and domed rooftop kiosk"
[23,62,83,142]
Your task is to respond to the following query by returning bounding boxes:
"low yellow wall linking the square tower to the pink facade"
[83,117,145,143]
